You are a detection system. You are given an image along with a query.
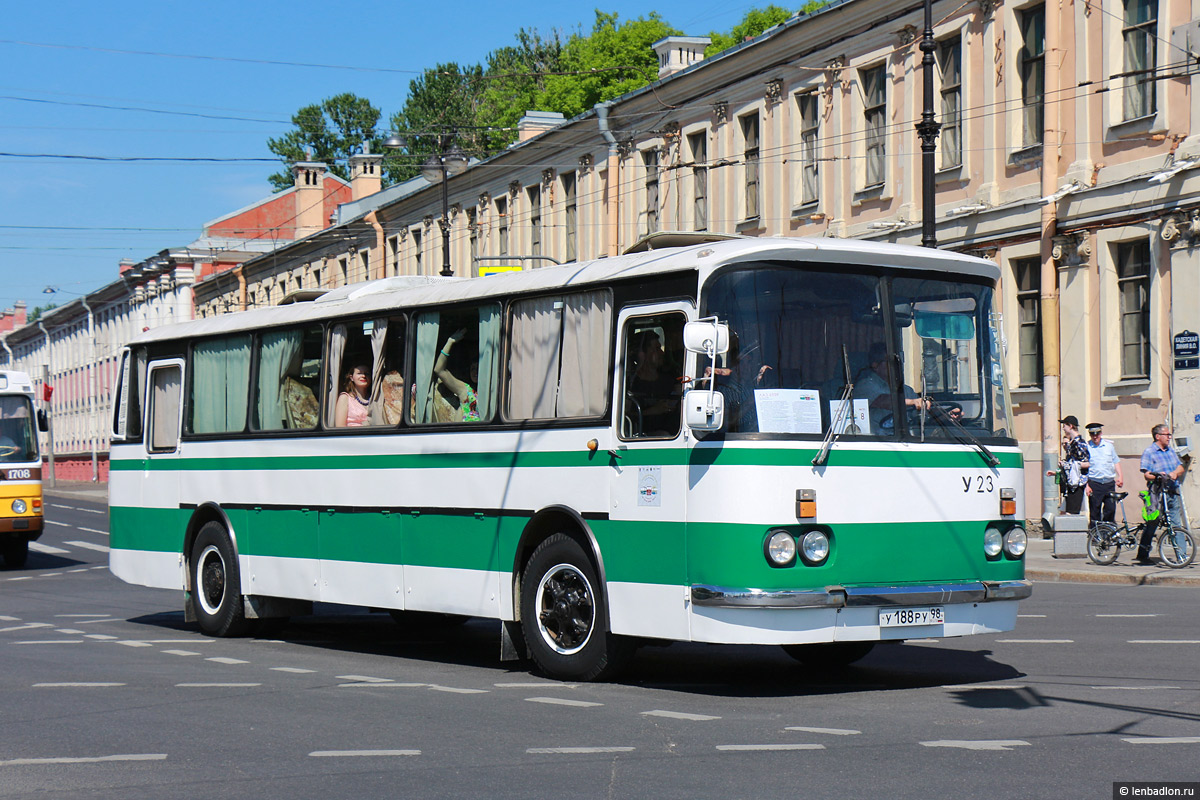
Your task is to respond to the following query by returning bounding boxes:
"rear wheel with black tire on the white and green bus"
[188,522,254,637]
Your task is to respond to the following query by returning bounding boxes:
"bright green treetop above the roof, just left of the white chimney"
[534,11,680,118]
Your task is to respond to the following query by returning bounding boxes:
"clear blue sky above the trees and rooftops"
[0,0,758,309]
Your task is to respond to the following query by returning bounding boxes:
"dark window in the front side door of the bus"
[620,314,684,439]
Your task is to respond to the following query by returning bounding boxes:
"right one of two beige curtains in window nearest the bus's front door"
[558,291,612,416]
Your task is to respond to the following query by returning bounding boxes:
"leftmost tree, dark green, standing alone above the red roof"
[266,92,383,192]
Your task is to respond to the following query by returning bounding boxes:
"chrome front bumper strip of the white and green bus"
[691,581,1033,608]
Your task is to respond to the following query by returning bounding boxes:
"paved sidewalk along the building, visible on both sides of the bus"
[46,481,1200,588]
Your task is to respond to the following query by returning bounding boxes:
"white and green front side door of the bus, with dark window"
[601,301,696,638]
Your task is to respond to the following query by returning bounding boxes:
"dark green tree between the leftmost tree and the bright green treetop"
[383,62,484,184]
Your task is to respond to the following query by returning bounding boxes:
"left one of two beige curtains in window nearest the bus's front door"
[506,297,563,420]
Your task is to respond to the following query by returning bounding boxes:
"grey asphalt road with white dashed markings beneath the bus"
[0,498,1200,800]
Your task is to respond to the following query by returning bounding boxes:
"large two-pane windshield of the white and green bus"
[697,264,1012,441]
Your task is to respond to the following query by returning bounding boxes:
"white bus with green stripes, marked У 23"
[109,239,1030,680]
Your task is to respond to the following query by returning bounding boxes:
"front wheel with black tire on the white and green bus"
[521,534,634,680]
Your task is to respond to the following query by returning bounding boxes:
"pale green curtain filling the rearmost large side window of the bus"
[192,336,250,433]
